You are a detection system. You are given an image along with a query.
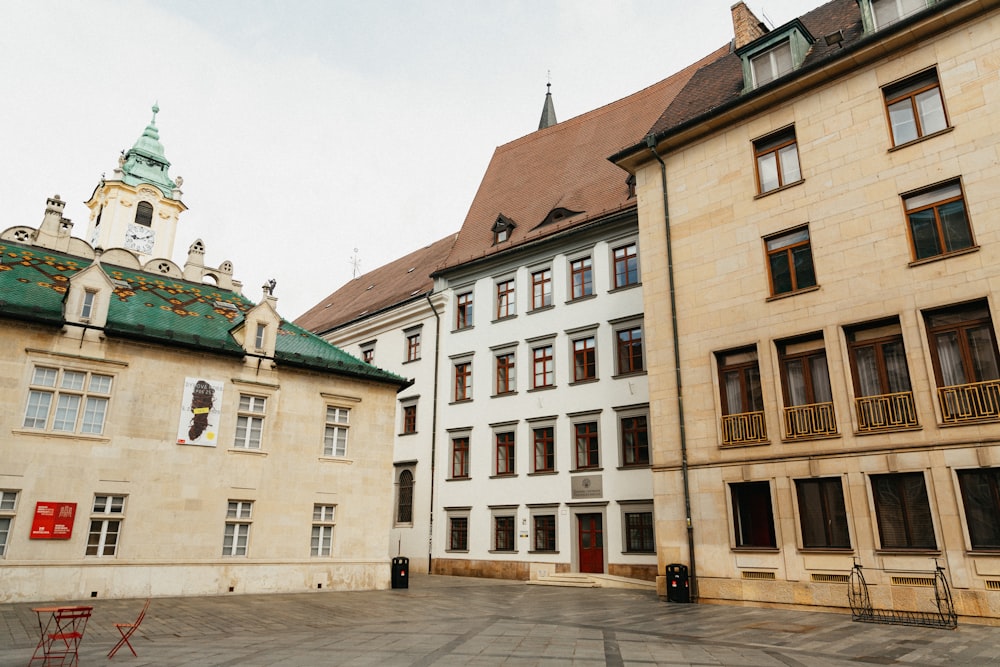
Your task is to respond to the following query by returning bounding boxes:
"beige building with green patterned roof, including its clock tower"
[0,111,406,602]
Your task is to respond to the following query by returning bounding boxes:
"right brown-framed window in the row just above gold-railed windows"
[903,181,975,260]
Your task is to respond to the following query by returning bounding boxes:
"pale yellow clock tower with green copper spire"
[86,105,187,262]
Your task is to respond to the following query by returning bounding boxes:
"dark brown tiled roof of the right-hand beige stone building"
[644,0,863,142]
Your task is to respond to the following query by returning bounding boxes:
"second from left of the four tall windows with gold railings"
[778,338,837,439]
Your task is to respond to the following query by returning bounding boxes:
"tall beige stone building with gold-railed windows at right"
[613,0,1000,620]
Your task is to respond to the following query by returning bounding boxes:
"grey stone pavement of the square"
[0,575,1000,667]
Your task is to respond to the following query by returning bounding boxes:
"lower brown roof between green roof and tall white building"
[295,234,457,334]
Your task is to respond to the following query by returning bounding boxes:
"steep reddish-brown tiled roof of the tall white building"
[434,45,729,268]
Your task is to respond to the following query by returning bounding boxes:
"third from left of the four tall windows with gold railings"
[847,320,917,431]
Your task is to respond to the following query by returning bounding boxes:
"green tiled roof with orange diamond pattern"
[0,241,406,385]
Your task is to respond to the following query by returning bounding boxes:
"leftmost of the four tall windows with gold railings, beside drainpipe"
[716,347,767,445]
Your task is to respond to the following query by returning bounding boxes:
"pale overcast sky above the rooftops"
[0,0,822,319]
